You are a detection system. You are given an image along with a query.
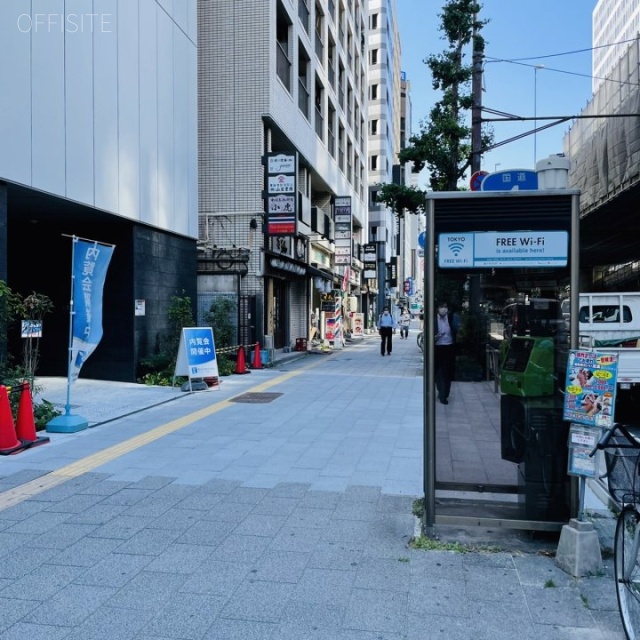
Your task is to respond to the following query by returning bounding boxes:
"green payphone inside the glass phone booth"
[500,336,555,398]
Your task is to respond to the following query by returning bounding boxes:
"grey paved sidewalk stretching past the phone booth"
[0,331,624,640]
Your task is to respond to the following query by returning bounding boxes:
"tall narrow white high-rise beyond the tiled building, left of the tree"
[368,0,402,318]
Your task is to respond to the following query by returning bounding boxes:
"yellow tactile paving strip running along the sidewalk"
[0,361,320,511]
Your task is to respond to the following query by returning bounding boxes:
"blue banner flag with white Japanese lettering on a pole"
[69,238,115,381]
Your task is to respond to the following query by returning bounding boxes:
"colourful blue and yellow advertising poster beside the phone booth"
[562,349,618,428]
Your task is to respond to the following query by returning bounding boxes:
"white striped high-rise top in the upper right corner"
[591,0,640,93]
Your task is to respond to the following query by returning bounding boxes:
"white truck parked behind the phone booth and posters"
[562,292,640,422]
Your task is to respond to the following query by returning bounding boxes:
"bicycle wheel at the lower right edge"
[614,505,640,640]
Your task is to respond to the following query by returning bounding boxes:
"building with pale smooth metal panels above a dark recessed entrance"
[0,0,198,381]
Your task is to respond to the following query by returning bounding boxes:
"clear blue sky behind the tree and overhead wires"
[396,0,597,188]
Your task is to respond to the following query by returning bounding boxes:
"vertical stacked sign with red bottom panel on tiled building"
[265,153,298,236]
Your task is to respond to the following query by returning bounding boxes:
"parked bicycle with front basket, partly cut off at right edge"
[590,423,640,640]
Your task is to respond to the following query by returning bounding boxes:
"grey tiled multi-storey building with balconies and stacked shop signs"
[198,0,368,349]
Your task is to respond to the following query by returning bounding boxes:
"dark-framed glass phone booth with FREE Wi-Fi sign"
[423,190,579,531]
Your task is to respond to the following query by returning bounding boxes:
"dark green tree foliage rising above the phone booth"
[378,0,493,215]
